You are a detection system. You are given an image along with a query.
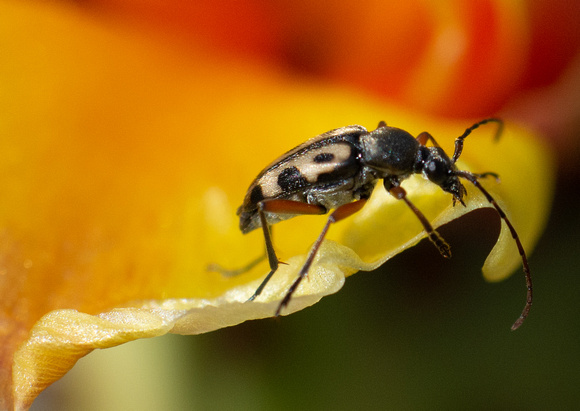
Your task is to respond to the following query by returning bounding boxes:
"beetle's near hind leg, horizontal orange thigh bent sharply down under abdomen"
[248,200,327,301]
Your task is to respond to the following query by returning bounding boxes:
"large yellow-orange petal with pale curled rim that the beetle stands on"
[0,3,552,408]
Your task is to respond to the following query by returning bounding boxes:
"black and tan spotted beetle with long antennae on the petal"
[212,118,532,330]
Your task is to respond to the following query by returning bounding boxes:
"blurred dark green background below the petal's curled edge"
[32,176,580,410]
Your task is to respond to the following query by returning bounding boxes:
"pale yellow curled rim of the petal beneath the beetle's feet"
[13,122,552,409]
